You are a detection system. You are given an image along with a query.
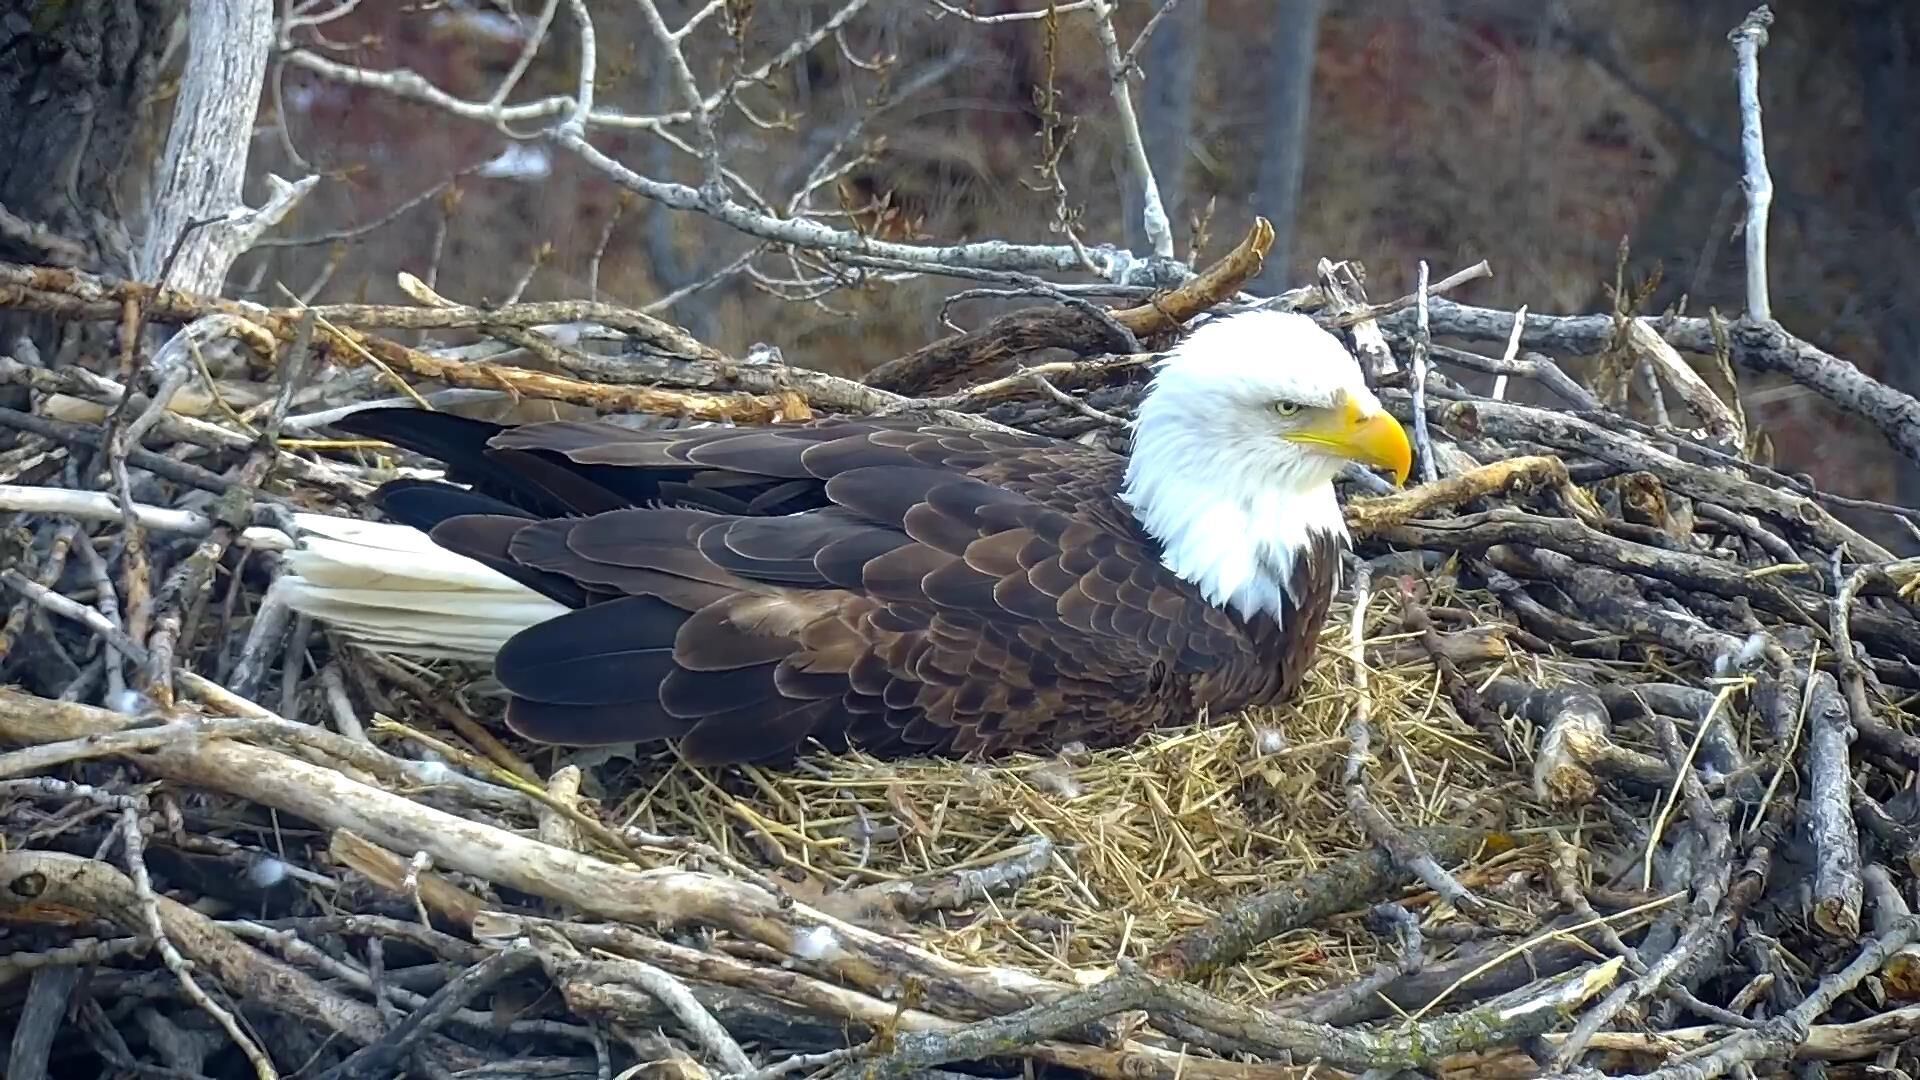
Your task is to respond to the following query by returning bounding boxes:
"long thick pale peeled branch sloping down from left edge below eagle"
[0,688,1066,1017]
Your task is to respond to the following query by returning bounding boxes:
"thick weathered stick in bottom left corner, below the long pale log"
[0,851,482,1068]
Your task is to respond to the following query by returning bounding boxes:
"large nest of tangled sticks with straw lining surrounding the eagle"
[0,242,1920,1080]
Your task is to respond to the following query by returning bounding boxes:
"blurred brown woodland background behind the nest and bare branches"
[56,0,1920,502]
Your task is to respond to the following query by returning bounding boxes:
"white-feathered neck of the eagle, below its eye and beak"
[1121,405,1348,626]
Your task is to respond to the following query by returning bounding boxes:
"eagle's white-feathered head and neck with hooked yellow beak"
[1121,311,1413,619]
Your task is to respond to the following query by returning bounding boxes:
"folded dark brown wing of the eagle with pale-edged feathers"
[340,409,1273,763]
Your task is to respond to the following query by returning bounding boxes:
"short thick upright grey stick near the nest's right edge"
[1807,671,1862,940]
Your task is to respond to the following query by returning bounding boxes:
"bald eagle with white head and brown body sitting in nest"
[282,311,1411,765]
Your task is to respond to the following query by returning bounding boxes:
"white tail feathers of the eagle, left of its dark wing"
[274,513,566,661]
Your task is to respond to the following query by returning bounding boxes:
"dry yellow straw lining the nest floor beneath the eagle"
[614,588,1520,1003]
